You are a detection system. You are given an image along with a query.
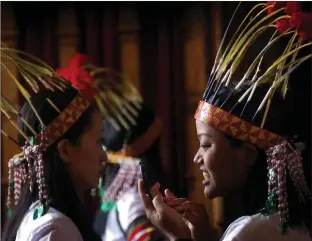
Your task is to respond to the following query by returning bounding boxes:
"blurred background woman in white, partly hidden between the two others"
[94,100,164,241]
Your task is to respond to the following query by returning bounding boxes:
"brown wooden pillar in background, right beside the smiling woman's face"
[184,3,211,215]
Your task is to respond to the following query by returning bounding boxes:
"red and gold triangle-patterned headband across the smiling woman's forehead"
[194,100,284,149]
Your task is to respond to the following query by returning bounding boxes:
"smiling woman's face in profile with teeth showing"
[194,120,256,199]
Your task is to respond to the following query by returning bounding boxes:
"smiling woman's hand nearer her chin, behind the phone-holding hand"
[164,189,218,241]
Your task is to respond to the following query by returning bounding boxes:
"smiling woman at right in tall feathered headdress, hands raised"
[139,2,312,241]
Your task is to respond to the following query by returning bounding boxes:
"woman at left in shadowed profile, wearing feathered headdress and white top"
[1,48,140,241]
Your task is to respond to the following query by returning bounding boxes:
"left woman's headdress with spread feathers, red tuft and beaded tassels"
[1,47,141,219]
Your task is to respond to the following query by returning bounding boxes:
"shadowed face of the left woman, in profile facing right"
[59,111,107,190]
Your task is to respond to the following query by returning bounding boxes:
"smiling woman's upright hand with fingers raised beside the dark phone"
[139,179,191,241]
